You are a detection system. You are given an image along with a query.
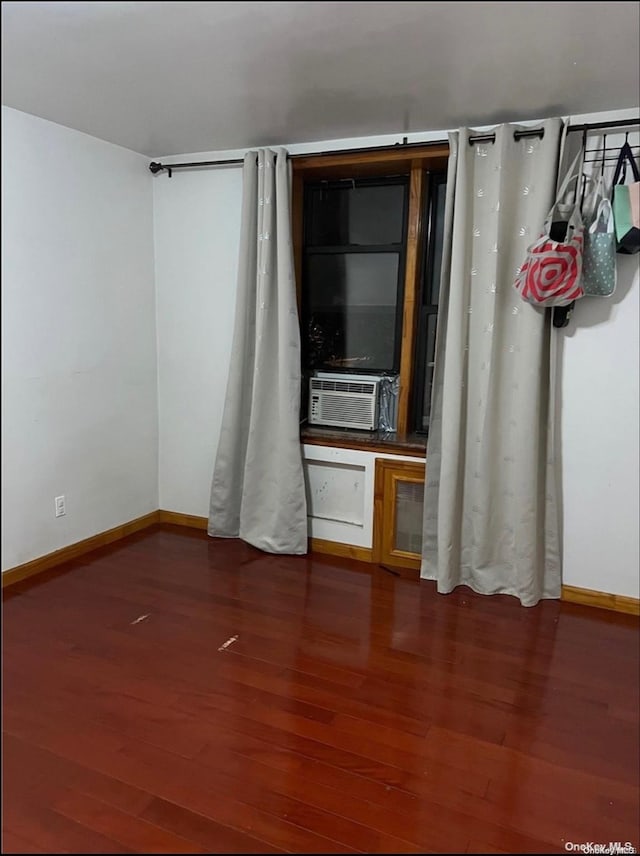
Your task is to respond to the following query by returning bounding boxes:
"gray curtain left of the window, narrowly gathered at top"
[208,149,307,554]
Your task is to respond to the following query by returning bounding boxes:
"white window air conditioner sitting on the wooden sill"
[309,372,380,431]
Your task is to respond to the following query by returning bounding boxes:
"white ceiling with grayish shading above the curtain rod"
[2,0,640,157]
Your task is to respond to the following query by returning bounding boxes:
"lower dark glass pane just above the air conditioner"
[303,247,400,371]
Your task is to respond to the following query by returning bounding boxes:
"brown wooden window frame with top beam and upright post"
[292,143,449,438]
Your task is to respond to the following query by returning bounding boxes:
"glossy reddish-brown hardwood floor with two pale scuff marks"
[2,526,640,853]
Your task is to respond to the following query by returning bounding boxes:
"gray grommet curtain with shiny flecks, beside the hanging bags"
[421,119,561,606]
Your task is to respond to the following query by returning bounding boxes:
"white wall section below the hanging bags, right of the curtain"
[560,255,640,598]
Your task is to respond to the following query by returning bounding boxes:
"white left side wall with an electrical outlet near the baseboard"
[2,107,158,569]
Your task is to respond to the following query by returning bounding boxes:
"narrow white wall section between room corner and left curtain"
[154,168,242,516]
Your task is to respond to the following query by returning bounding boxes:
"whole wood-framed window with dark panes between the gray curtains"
[293,144,448,435]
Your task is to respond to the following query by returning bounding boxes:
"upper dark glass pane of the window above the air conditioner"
[307,184,406,247]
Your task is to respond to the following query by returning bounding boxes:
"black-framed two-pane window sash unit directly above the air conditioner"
[301,177,409,374]
